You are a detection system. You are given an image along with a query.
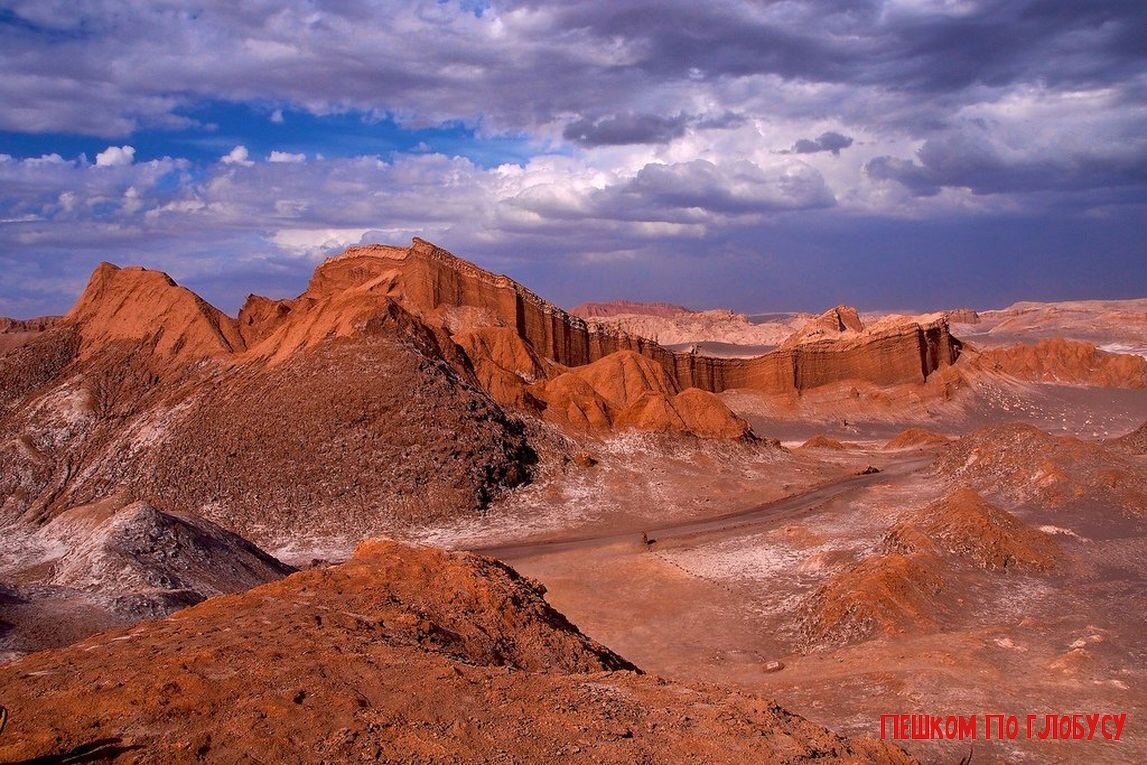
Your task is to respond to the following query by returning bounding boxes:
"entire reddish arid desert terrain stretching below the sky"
[0,240,1147,764]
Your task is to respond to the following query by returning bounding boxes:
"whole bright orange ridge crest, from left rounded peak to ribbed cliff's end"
[55,240,960,406]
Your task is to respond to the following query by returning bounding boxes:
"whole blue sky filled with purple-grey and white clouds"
[0,0,1147,317]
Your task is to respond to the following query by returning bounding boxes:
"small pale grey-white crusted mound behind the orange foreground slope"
[0,495,294,661]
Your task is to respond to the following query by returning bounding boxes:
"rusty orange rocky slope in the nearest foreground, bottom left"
[0,542,911,763]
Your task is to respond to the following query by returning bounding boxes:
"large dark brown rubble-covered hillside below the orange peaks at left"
[0,291,537,547]
